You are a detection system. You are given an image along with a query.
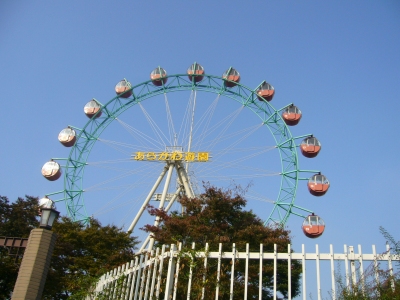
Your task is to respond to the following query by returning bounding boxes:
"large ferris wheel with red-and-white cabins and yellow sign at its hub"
[42,63,330,243]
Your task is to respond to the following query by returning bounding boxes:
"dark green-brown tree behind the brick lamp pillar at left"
[0,196,138,299]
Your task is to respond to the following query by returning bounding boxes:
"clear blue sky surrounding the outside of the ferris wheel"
[0,0,400,296]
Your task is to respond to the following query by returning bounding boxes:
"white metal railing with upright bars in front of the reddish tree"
[88,244,400,300]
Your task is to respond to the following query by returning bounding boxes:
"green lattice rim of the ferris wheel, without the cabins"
[47,74,318,225]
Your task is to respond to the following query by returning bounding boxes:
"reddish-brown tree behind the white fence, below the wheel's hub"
[143,186,301,299]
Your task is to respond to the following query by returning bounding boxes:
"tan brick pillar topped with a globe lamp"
[11,199,60,300]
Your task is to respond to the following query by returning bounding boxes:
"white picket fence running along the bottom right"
[88,244,400,300]
